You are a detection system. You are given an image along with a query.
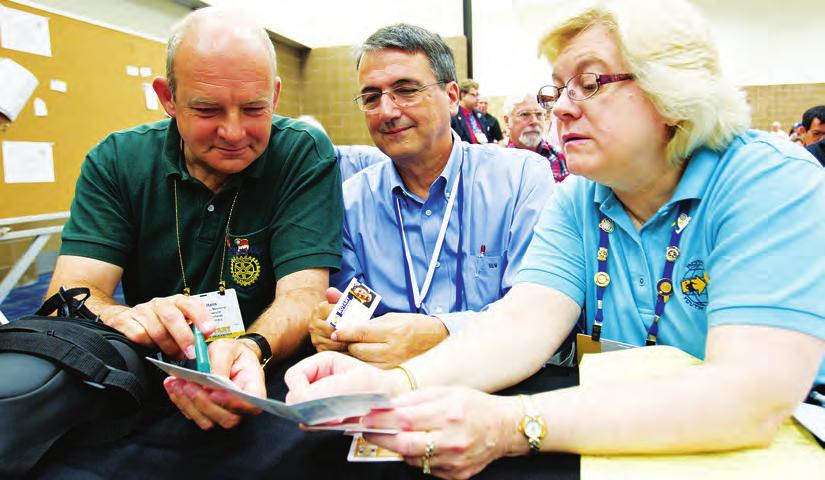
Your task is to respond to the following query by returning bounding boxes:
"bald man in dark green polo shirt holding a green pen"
[49,7,343,430]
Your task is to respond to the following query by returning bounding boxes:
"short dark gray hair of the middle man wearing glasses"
[355,23,456,83]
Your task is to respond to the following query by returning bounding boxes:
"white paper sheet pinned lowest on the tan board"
[3,141,54,183]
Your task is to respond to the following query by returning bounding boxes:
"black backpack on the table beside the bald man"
[0,288,169,478]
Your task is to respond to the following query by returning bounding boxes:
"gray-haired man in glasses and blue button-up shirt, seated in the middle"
[310,24,554,368]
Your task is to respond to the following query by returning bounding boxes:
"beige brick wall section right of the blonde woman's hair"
[745,83,825,132]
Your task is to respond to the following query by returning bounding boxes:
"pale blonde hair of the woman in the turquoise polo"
[540,0,750,165]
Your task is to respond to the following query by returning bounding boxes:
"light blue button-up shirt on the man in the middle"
[330,133,556,333]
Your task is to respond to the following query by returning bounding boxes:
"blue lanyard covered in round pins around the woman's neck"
[590,201,690,345]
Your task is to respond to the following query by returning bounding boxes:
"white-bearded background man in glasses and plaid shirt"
[504,91,569,183]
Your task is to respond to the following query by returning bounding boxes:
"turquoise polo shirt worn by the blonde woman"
[516,131,825,383]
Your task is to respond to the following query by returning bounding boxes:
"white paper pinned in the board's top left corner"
[0,6,52,57]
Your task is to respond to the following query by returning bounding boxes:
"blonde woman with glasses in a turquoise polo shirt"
[286,0,825,477]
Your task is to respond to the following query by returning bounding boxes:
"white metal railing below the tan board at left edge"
[0,212,69,304]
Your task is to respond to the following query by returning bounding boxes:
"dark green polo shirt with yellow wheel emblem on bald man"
[60,116,343,325]
